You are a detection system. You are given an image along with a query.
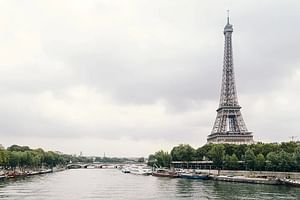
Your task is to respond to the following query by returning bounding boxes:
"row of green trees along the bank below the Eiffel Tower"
[148,142,300,172]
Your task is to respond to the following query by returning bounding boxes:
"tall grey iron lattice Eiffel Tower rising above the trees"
[207,15,253,144]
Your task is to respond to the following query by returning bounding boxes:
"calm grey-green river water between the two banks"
[0,169,300,200]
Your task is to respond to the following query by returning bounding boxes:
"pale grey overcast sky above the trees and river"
[0,0,300,156]
